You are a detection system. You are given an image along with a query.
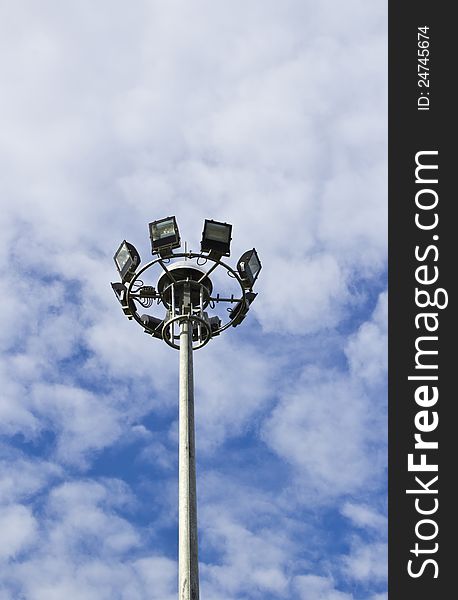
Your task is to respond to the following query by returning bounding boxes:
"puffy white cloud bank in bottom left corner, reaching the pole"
[0,480,176,600]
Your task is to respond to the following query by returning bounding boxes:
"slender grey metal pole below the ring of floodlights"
[178,319,199,600]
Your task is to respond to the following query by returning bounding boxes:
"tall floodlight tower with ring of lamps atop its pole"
[111,217,261,600]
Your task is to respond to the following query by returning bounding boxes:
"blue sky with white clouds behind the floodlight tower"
[0,0,387,600]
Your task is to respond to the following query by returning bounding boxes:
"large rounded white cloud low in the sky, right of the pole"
[263,373,383,497]
